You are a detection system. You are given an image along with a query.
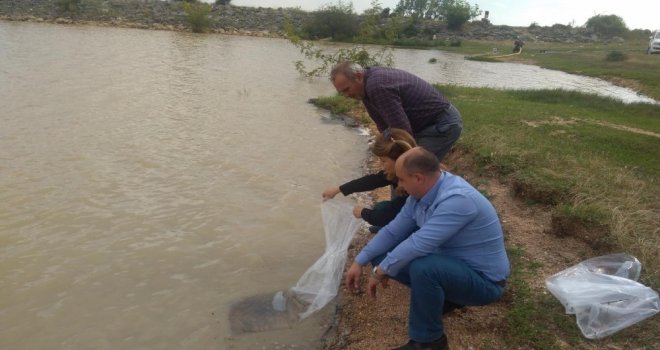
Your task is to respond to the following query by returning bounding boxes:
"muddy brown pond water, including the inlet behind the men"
[0,22,652,349]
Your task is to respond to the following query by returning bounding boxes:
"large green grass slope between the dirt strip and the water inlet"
[439,86,660,288]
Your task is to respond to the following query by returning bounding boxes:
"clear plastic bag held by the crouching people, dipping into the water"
[288,200,361,320]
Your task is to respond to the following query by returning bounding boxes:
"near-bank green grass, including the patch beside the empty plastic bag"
[315,86,660,349]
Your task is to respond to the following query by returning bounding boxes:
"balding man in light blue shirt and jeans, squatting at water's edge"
[345,147,510,350]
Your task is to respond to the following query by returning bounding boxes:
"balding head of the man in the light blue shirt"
[395,147,440,199]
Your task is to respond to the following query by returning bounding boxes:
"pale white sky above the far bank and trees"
[226,0,660,30]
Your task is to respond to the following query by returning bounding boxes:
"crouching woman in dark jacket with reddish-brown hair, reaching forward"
[322,128,416,228]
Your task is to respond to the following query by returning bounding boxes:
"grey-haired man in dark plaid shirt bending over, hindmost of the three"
[330,61,463,160]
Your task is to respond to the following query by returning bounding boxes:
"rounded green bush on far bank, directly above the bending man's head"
[304,0,358,40]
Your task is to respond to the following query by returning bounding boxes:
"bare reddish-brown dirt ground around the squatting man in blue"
[325,133,656,350]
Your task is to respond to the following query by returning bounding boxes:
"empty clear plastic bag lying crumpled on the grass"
[545,254,660,339]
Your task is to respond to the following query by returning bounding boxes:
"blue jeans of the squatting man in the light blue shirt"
[371,254,504,343]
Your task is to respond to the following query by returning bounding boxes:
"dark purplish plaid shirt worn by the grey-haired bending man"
[362,67,450,135]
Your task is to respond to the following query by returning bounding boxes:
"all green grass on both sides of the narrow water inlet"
[310,37,660,349]
